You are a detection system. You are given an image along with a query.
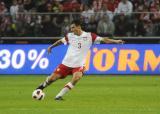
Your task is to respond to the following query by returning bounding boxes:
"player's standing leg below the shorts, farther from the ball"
[55,71,83,100]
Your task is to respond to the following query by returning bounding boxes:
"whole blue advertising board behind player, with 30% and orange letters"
[0,44,160,74]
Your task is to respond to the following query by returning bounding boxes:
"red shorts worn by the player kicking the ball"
[54,64,85,78]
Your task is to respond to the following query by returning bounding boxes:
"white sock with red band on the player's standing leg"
[56,82,74,98]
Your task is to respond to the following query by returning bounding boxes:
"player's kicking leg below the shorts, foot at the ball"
[36,72,61,90]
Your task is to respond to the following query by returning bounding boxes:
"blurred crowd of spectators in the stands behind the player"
[0,0,160,37]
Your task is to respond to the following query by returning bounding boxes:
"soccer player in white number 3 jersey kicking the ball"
[33,20,124,100]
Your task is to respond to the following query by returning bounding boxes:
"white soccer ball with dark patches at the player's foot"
[32,89,45,100]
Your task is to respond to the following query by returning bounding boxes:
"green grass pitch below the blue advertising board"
[0,75,160,114]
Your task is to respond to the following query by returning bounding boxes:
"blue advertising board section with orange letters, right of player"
[86,44,160,74]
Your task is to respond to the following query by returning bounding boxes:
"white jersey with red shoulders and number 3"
[62,31,102,68]
